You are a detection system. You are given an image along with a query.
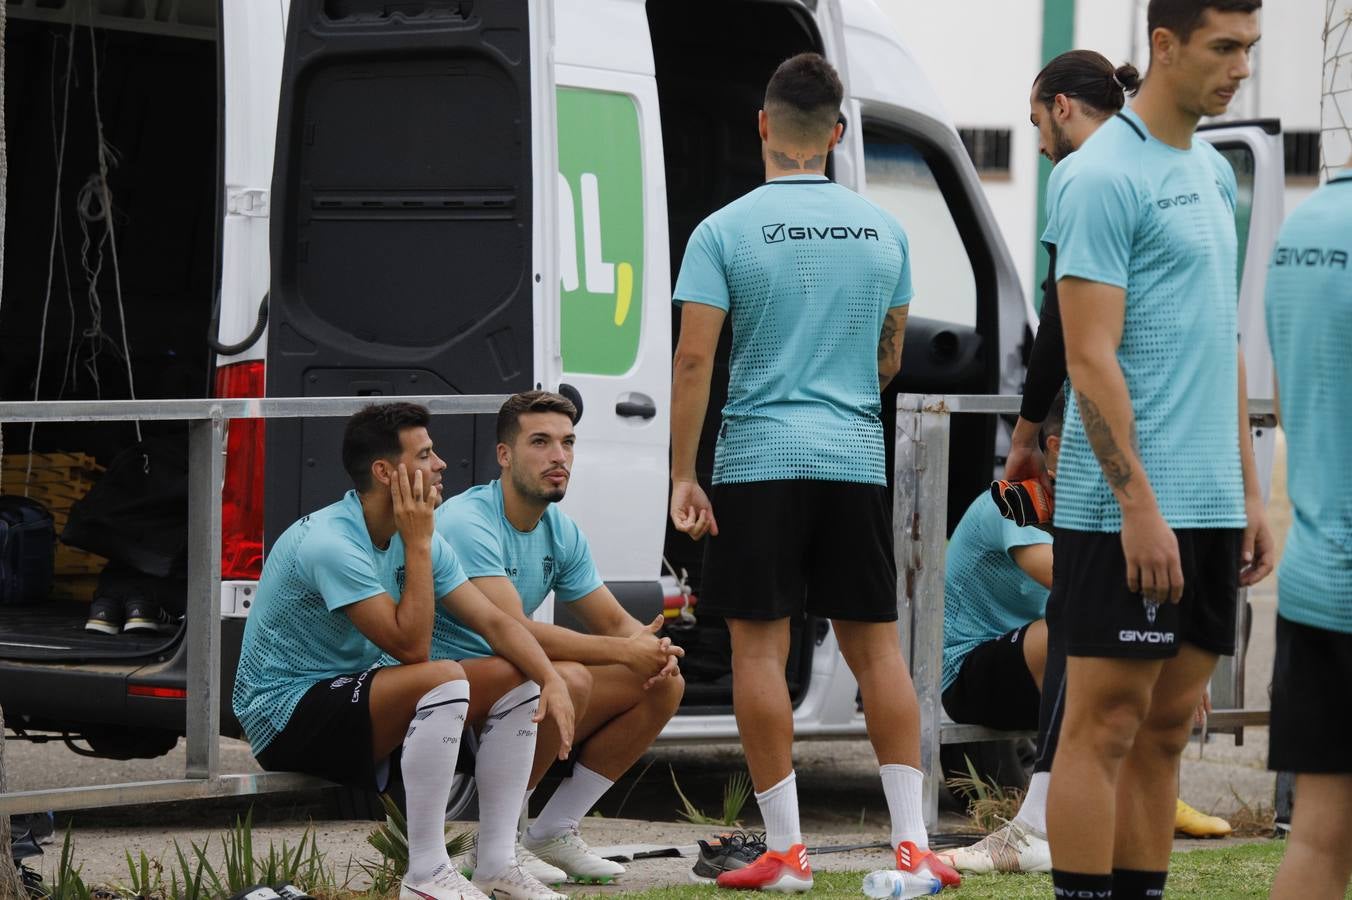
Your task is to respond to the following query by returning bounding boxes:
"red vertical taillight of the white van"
[216,361,264,581]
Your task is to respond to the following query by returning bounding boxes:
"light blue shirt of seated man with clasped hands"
[431,481,604,659]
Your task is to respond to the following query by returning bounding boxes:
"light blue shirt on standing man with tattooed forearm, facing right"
[1042,111,1245,532]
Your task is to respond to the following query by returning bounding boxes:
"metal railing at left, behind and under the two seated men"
[0,395,507,815]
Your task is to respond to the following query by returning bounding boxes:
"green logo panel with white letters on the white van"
[558,88,644,374]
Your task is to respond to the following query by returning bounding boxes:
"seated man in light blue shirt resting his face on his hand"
[234,403,573,900]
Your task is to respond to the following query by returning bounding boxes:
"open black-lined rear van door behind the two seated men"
[265,0,557,541]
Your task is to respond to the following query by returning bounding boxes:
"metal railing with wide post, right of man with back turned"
[892,393,1275,828]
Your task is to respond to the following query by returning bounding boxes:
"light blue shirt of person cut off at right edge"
[1267,169,1352,632]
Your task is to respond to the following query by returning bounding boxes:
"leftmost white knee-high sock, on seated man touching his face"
[402,678,469,884]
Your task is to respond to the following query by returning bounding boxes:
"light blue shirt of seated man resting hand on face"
[240,491,466,754]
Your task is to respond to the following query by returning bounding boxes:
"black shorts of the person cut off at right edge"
[1268,615,1352,772]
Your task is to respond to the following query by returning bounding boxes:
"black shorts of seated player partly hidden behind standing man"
[941,623,1041,731]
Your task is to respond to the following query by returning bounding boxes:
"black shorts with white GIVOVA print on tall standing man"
[1048,528,1244,659]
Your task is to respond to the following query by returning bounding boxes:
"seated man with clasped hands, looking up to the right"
[431,391,684,882]
